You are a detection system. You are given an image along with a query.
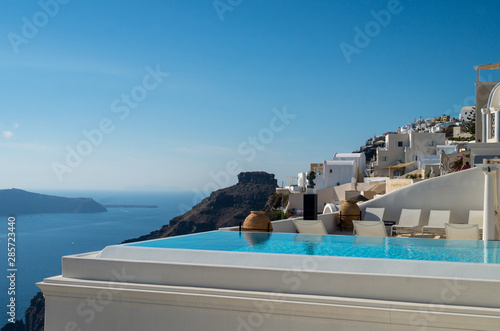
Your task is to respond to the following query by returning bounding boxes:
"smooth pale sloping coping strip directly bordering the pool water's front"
[96,245,500,280]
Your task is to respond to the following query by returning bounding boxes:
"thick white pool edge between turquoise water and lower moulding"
[58,249,500,309]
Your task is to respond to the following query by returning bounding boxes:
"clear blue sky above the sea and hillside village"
[0,0,500,192]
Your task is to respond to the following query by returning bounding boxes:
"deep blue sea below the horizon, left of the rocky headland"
[0,191,193,328]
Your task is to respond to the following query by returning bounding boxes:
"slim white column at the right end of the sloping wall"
[483,165,496,241]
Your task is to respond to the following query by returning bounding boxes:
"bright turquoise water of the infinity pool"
[125,231,500,263]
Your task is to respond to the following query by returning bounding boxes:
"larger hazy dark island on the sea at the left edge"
[0,188,108,216]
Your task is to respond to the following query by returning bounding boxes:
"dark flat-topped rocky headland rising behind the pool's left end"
[125,172,278,242]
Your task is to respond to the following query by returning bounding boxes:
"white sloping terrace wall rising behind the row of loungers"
[359,168,484,224]
